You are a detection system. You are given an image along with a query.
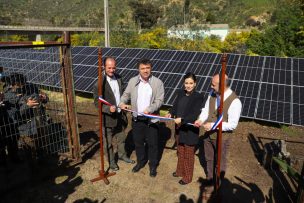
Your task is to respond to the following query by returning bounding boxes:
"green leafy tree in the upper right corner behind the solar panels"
[246,0,304,57]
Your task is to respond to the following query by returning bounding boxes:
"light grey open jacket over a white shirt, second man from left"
[120,75,165,117]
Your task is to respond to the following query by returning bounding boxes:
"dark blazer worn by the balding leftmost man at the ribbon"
[93,74,127,127]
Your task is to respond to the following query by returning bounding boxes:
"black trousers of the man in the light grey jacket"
[132,120,158,168]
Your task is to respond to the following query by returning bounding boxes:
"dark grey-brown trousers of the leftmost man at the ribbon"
[103,126,126,164]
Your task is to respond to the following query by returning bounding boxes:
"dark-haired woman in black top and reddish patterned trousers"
[167,73,203,185]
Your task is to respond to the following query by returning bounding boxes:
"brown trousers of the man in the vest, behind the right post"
[203,135,230,179]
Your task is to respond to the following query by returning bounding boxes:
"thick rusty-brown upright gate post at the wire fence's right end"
[61,31,81,163]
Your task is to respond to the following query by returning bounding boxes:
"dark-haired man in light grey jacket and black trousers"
[120,59,165,177]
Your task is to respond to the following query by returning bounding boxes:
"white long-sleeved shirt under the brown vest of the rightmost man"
[199,88,242,131]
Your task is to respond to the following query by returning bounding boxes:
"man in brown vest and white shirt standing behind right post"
[195,74,242,189]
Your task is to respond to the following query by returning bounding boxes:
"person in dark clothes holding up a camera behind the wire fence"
[5,73,48,162]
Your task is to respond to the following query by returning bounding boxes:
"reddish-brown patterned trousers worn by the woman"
[176,144,195,183]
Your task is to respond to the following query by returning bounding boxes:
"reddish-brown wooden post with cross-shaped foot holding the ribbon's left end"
[91,48,116,185]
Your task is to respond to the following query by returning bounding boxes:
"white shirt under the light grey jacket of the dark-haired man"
[137,77,152,113]
